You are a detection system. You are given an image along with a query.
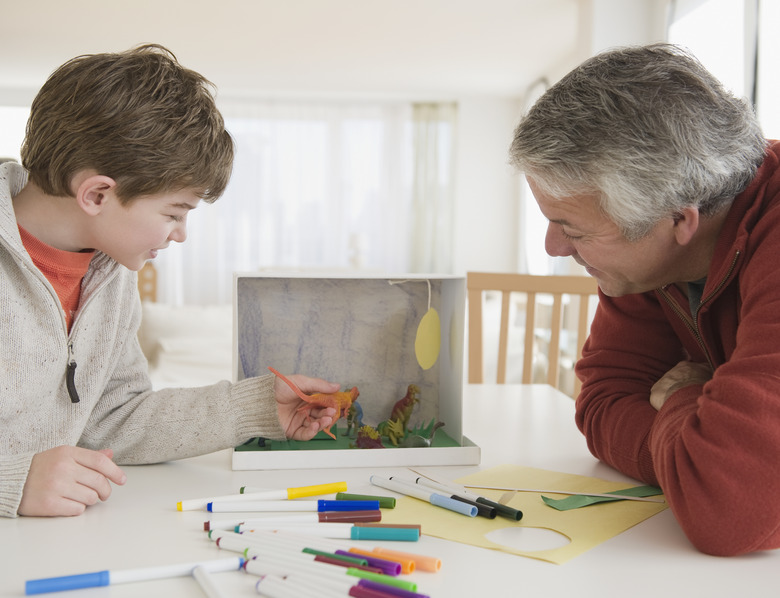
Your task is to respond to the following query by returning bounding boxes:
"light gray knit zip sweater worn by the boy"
[0,162,284,517]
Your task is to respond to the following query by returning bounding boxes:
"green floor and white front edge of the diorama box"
[233,425,480,470]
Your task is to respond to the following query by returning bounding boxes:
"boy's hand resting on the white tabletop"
[18,446,127,517]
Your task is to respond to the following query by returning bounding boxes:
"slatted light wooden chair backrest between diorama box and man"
[466,272,598,397]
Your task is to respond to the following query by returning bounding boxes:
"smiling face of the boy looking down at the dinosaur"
[96,189,200,270]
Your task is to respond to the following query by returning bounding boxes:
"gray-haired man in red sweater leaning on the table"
[510,44,780,555]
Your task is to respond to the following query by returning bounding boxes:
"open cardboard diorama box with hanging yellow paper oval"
[233,274,480,470]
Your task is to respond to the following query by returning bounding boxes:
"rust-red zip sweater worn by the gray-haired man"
[576,142,780,555]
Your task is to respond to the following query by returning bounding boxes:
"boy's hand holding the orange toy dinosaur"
[274,374,341,440]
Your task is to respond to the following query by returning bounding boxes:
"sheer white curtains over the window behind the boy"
[155,102,454,304]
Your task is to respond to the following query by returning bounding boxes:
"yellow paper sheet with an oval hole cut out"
[382,465,667,564]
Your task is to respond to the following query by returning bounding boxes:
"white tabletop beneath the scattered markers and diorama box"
[0,385,780,598]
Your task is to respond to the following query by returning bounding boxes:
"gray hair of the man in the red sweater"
[510,44,766,241]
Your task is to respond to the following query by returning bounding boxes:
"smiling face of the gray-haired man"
[528,178,682,297]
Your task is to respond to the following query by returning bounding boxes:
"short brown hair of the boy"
[21,44,233,204]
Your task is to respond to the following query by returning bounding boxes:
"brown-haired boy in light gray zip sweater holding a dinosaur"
[0,45,339,517]
